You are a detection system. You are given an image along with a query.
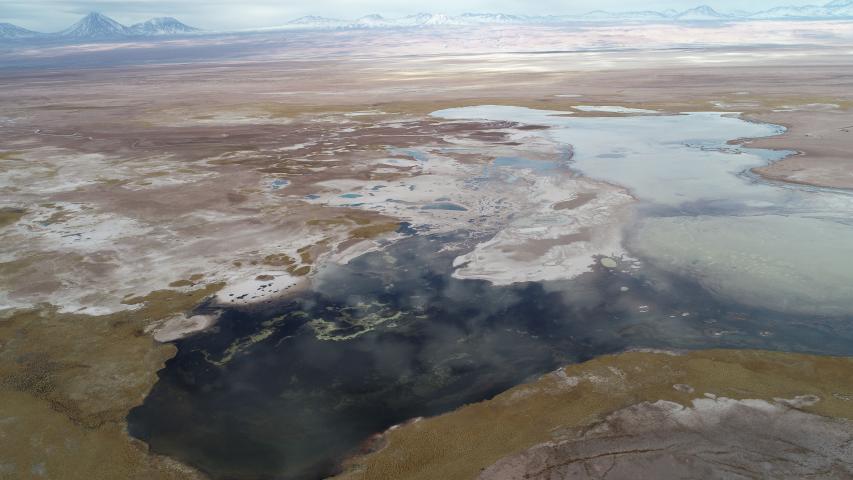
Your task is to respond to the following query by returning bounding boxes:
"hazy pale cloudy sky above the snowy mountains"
[0,0,828,31]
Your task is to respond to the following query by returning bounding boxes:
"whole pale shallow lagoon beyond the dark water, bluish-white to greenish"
[434,106,853,316]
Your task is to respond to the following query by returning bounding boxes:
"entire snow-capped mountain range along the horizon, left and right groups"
[5,0,853,41]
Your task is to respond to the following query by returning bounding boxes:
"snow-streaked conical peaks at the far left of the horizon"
[0,12,200,41]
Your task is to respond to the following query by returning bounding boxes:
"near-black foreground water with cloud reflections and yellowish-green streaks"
[128,231,853,479]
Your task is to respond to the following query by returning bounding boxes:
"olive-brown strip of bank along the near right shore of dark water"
[335,350,853,480]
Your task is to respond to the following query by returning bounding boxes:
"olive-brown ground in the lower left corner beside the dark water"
[0,285,220,480]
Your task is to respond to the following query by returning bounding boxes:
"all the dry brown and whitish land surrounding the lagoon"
[0,22,853,479]
